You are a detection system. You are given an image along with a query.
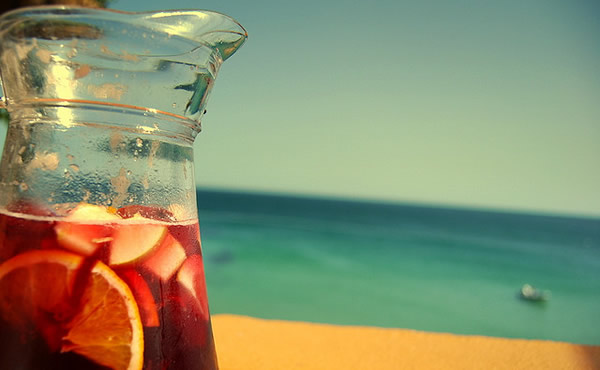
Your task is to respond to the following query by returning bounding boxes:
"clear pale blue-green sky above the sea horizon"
[1,0,600,217]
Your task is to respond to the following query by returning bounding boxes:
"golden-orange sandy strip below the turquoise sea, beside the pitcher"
[213,315,600,370]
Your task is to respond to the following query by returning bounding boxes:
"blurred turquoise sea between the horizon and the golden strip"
[198,191,600,345]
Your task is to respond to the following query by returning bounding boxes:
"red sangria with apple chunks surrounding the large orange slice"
[0,208,217,370]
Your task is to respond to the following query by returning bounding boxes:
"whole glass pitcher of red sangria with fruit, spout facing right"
[0,7,247,370]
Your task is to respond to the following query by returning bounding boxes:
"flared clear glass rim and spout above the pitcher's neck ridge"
[0,6,248,136]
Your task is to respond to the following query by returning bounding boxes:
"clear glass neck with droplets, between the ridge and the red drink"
[0,107,198,221]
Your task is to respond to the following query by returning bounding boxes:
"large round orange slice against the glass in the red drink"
[0,250,144,370]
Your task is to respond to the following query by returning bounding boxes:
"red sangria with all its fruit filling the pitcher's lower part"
[0,204,216,370]
